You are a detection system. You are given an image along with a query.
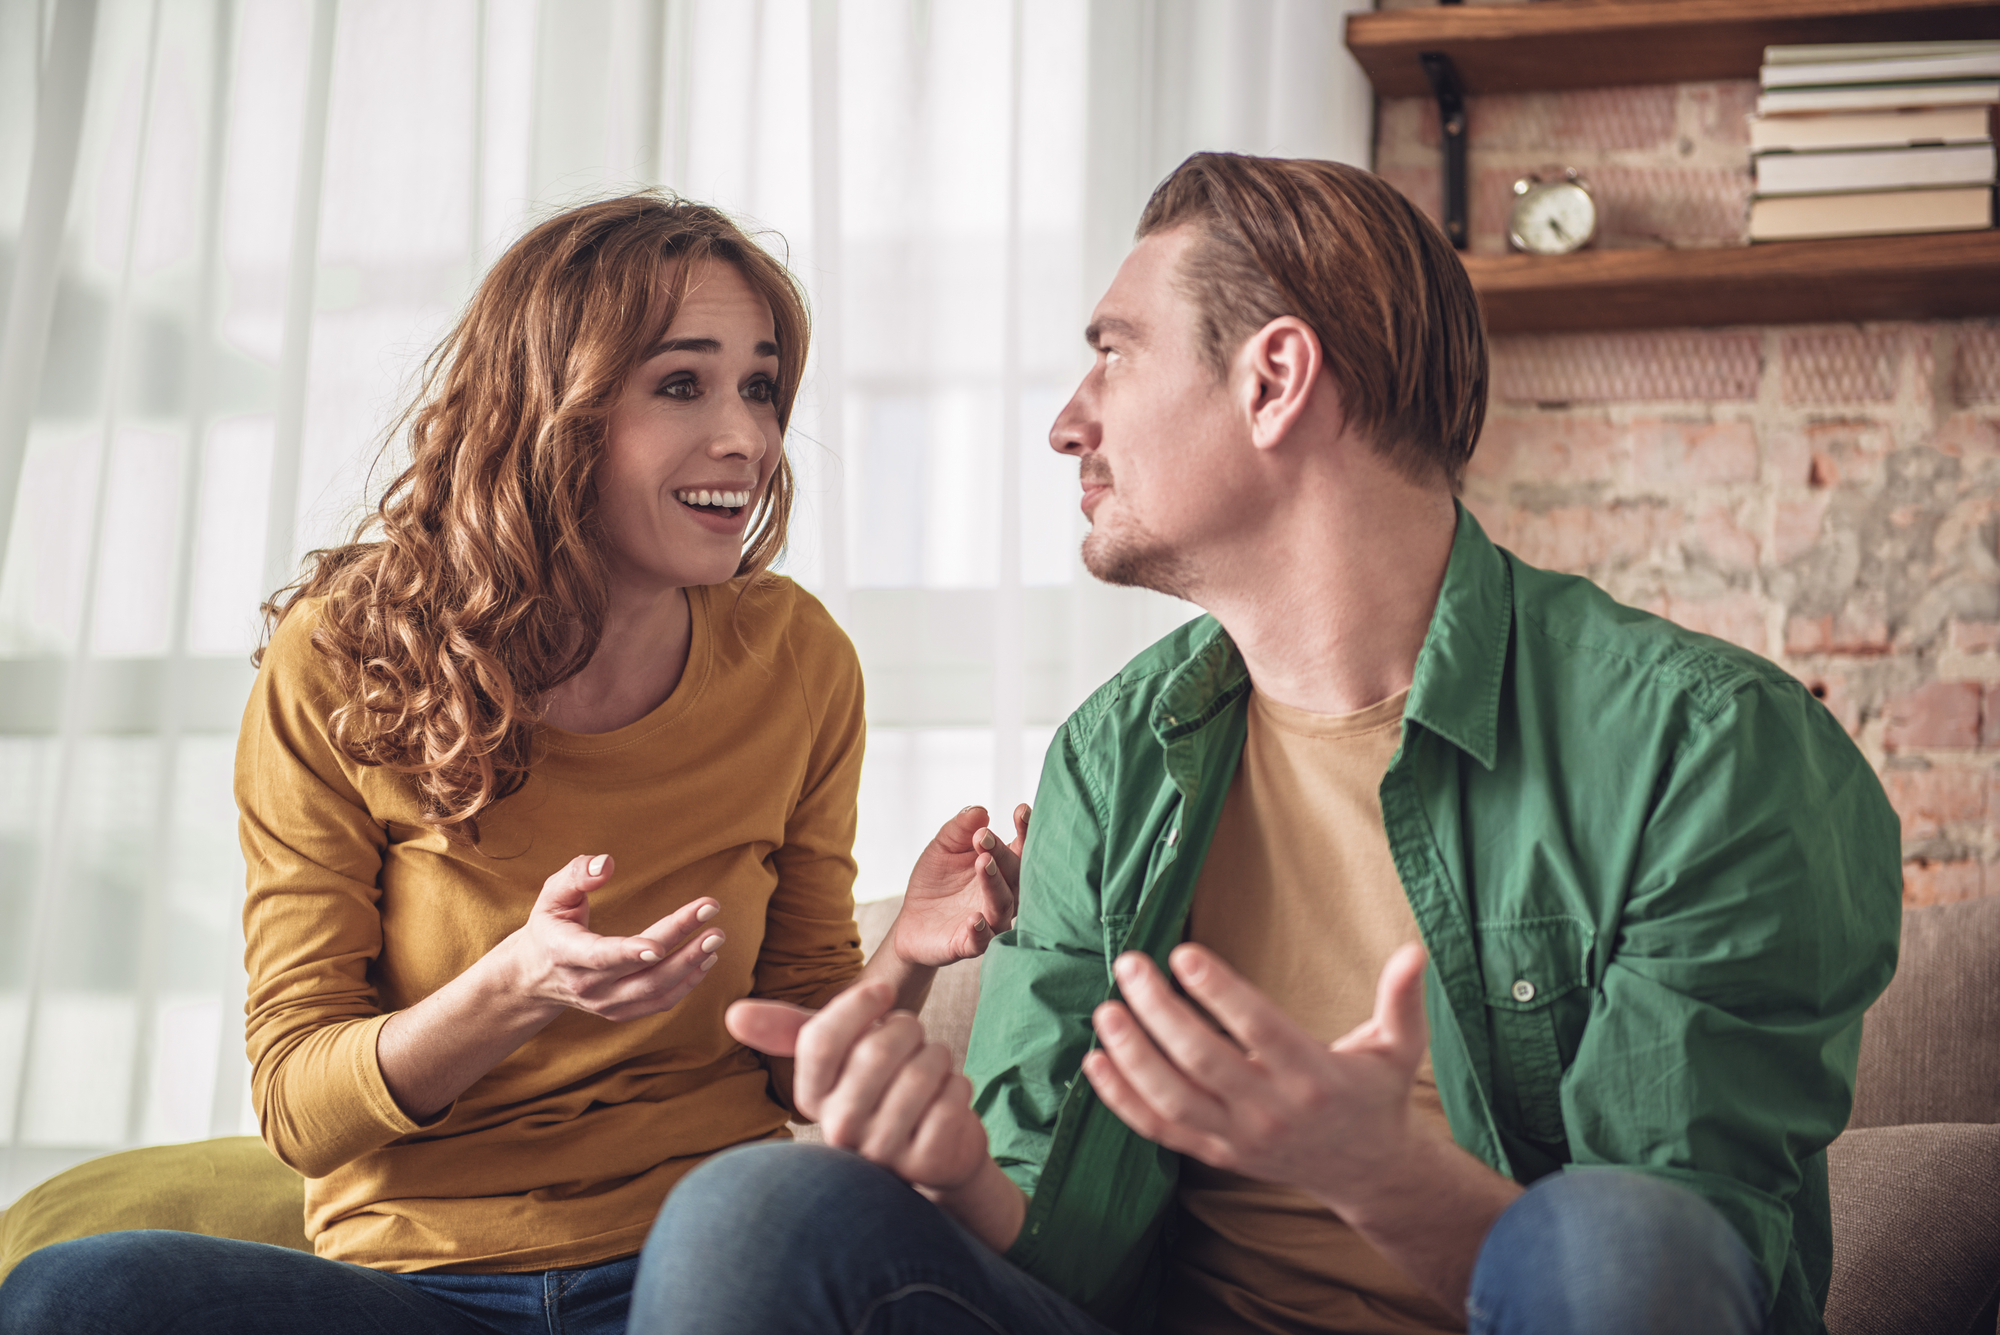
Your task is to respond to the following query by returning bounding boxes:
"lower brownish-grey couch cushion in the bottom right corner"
[1826,1123,2000,1335]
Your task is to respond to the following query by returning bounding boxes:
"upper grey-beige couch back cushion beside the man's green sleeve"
[1848,897,2000,1129]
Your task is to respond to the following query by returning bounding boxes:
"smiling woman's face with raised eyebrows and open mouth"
[598,262,784,594]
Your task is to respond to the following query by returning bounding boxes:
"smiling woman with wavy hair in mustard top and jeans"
[0,194,1018,1333]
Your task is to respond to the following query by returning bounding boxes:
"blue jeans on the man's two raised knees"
[632,1145,1764,1335]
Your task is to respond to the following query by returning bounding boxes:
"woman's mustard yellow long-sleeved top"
[236,576,864,1271]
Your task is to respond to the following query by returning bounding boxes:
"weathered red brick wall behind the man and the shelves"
[1376,82,2000,903]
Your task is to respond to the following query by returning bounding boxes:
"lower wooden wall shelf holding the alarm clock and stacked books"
[1462,230,2000,334]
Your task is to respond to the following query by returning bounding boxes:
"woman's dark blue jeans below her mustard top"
[0,1229,638,1335]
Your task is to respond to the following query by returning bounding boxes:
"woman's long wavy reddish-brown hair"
[256,192,808,845]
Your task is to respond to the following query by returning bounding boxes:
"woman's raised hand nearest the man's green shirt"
[890,803,1030,969]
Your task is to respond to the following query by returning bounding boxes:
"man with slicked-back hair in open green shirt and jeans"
[640,154,1900,1333]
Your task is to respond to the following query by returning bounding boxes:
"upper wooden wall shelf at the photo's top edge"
[1346,0,2000,98]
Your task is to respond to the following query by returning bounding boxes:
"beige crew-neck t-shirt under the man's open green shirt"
[1158,691,1462,1335]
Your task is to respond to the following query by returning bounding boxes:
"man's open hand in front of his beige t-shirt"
[1084,945,1430,1213]
